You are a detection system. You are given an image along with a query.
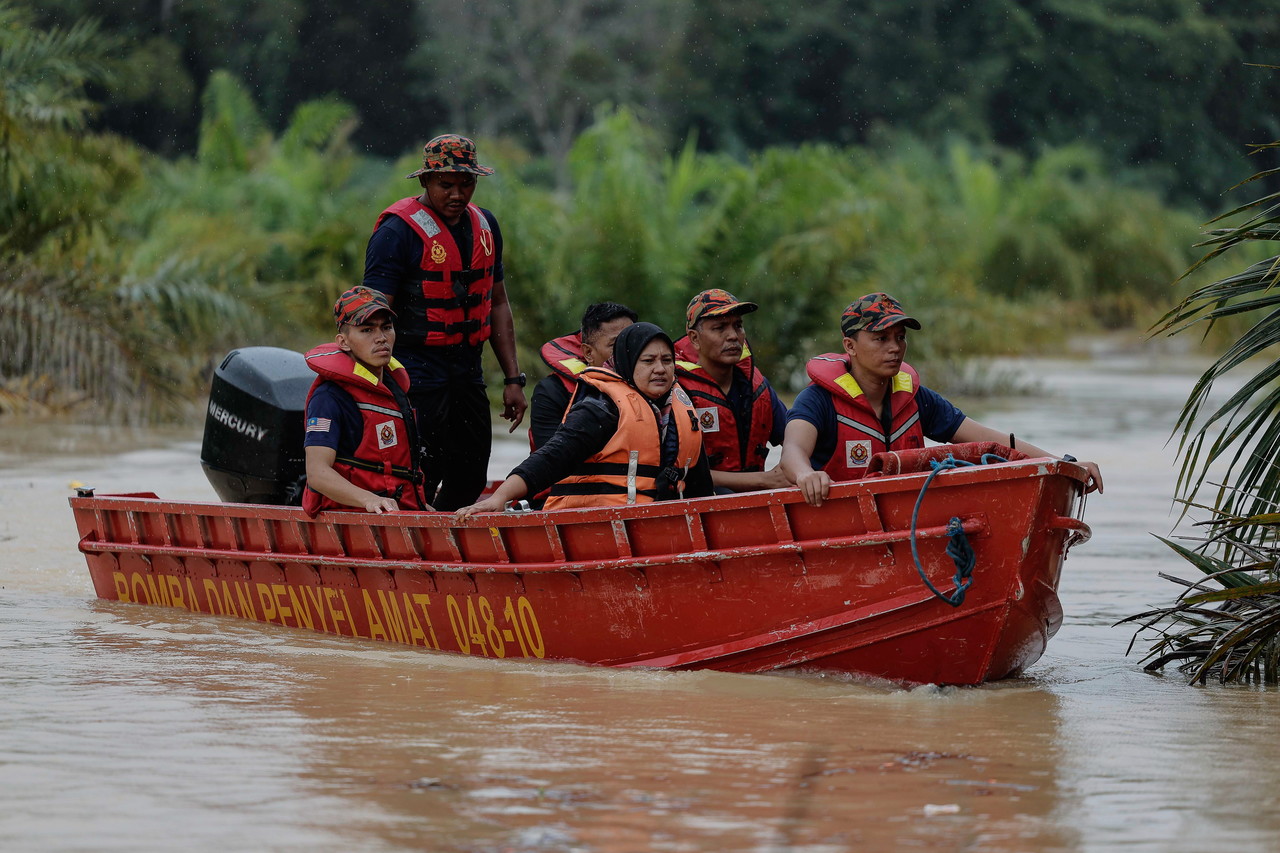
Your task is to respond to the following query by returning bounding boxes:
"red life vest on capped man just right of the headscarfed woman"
[676,336,773,471]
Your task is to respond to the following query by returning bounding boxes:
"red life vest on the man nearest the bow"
[805,352,924,482]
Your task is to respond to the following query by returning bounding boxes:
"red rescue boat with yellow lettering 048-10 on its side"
[70,444,1089,684]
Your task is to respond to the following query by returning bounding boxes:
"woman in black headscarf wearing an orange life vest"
[457,323,713,519]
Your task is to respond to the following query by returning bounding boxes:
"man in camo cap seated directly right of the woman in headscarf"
[676,288,791,493]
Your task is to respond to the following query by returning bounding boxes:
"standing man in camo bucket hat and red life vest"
[364,133,527,510]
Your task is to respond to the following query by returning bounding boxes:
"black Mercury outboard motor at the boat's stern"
[200,347,316,506]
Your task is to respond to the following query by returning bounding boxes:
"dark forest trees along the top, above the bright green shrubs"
[27,0,1280,201]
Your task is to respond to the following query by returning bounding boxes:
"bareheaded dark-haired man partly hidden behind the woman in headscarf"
[529,302,640,450]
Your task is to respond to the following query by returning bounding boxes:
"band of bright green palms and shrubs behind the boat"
[0,0,1239,419]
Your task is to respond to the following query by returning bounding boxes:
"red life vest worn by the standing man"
[374,199,495,347]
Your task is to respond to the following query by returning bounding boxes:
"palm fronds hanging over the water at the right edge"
[1125,114,1280,684]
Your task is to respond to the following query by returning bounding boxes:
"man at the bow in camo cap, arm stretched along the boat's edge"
[782,293,1102,506]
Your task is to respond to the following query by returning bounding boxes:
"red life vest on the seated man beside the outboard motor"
[302,343,424,517]
